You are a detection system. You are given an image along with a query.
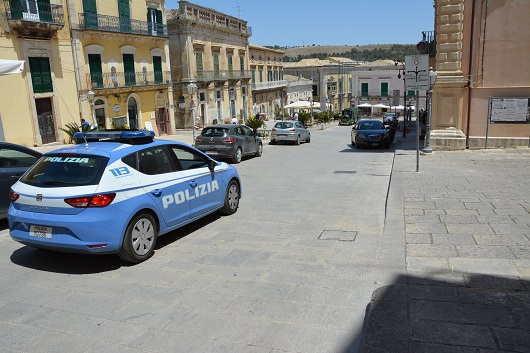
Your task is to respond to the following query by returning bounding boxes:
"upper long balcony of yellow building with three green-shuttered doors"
[79,12,168,37]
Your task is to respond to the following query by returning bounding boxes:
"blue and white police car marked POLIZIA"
[8,130,241,263]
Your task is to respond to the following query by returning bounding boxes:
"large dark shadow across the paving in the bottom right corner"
[354,273,530,353]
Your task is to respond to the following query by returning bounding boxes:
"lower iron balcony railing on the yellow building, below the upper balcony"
[87,71,171,89]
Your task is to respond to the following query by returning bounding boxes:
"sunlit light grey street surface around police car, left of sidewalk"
[0,127,394,353]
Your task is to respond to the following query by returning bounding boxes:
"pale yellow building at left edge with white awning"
[0,0,79,146]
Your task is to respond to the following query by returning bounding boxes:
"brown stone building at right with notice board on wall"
[420,0,530,149]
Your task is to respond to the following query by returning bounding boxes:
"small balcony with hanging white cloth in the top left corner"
[4,0,64,38]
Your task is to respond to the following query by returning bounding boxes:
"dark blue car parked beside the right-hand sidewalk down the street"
[351,119,394,148]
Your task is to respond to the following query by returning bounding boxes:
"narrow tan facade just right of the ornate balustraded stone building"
[249,44,287,119]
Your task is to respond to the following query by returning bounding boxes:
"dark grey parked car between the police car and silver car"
[195,124,263,163]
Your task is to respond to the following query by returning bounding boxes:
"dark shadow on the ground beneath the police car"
[8,210,220,274]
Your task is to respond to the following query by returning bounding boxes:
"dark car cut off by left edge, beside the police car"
[0,142,42,219]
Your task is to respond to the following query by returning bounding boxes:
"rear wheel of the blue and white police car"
[118,213,158,264]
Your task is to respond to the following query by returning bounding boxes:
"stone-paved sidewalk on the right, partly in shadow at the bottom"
[363,120,530,353]
